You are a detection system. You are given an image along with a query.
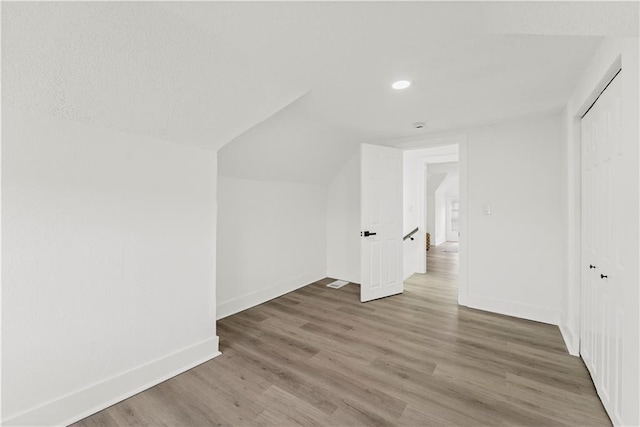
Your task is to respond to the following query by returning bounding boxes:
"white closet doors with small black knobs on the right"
[580,70,638,425]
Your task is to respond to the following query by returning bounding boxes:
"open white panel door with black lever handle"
[360,144,404,302]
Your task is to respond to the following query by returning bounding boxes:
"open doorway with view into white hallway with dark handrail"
[403,136,467,305]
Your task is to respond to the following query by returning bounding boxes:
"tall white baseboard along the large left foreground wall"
[2,337,220,426]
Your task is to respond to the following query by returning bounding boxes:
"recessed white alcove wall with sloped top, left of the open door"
[217,105,350,318]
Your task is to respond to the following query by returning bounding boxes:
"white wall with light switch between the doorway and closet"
[466,115,566,324]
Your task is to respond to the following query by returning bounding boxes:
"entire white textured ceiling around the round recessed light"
[2,2,638,154]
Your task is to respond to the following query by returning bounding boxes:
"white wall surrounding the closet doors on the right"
[560,37,640,425]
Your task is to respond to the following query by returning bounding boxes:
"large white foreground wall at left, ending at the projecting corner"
[2,108,218,425]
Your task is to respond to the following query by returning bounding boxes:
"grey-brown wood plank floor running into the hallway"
[76,245,610,427]
